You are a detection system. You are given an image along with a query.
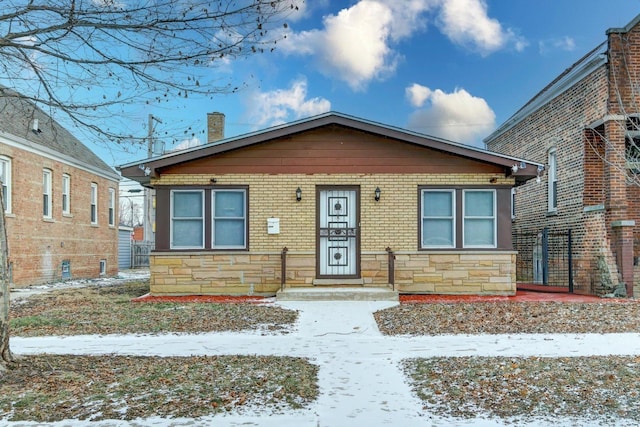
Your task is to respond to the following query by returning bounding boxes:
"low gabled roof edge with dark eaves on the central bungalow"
[117,112,544,184]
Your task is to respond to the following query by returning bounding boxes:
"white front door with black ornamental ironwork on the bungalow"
[317,187,360,278]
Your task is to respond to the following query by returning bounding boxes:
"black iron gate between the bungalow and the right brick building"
[513,228,573,293]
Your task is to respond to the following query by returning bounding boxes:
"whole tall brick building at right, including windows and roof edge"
[485,15,640,295]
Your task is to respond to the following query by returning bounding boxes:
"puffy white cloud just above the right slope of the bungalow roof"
[406,84,496,147]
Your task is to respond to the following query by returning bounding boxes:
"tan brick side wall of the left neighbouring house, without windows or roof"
[0,143,118,287]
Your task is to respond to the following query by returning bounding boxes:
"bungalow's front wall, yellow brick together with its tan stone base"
[151,174,515,295]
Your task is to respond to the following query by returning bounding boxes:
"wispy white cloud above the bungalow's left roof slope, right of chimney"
[246,78,331,128]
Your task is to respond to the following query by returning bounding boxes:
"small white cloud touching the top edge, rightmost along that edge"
[439,0,527,55]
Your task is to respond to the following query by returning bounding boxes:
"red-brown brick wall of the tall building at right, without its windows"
[489,20,640,293]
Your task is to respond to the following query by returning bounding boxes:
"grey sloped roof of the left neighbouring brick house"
[0,86,121,180]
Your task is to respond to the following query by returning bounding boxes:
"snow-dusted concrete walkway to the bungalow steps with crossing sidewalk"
[11,301,640,427]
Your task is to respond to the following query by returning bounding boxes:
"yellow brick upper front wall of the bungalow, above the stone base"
[153,174,513,252]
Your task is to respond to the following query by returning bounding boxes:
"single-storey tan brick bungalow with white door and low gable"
[119,113,543,295]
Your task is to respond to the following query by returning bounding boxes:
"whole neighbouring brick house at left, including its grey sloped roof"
[0,88,120,286]
